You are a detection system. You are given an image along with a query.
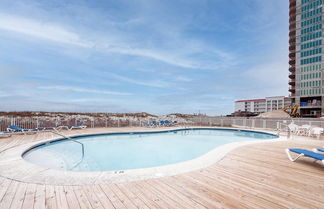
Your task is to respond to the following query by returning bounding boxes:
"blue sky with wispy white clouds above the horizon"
[0,0,288,115]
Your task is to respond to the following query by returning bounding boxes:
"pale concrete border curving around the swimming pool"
[0,127,286,185]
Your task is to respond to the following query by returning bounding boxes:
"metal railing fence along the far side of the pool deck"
[0,115,324,131]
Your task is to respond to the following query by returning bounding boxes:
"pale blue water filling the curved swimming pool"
[23,129,277,171]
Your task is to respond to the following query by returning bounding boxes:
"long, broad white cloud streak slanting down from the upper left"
[0,13,235,70]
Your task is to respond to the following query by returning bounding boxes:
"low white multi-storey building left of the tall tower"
[234,96,291,114]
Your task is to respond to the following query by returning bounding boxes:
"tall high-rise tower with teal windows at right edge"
[289,0,324,117]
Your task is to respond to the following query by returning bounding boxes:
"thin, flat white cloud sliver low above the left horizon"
[38,86,130,95]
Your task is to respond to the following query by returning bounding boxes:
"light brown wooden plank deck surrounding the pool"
[0,129,324,209]
